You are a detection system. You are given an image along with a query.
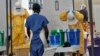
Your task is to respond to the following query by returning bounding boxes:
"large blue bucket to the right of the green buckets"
[66,29,80,45]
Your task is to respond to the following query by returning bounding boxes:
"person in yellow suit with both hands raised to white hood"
[60,11,84,54]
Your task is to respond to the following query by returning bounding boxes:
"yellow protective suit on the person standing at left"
[8,9,29,51]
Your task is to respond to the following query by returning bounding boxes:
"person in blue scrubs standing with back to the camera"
[25,3,49,56]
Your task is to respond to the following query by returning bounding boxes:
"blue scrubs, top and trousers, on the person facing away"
[25,14,48,56]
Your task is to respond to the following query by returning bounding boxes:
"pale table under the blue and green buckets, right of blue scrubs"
[43,45,79,56]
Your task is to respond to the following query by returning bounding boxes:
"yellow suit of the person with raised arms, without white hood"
[60,11,84,54]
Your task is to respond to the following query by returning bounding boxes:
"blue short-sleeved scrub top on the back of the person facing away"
[27,13,48,39]
